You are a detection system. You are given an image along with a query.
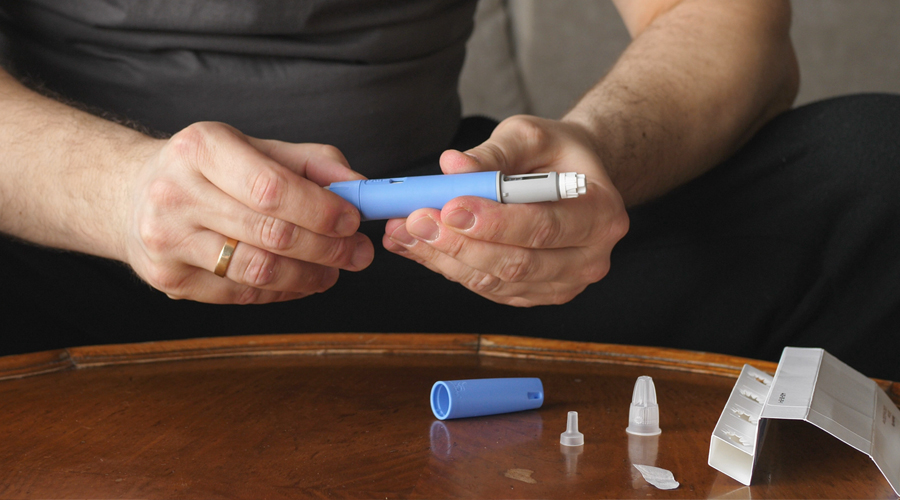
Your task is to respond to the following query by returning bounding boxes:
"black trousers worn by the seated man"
[0,95,900,380]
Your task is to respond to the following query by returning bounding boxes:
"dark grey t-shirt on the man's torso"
[0,0,475,176]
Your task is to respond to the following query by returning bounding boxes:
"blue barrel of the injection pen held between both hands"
[328,172,500,220]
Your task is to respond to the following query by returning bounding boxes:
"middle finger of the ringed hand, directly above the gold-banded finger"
[190,185,375,271]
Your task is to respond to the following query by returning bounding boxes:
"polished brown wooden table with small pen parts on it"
[0,334,900,499]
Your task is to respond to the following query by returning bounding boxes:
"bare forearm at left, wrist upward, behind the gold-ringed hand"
[0,70,154,260]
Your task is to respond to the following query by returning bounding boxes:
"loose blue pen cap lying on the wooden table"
[431,378,544,420]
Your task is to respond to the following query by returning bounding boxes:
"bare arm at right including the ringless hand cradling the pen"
[383,0,798,306]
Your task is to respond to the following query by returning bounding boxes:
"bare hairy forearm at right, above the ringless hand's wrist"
[563,0,799,205]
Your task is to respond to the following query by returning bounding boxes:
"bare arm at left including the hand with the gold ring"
[0,71,373,303]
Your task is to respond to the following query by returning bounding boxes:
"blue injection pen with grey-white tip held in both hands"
[328,172,586,220]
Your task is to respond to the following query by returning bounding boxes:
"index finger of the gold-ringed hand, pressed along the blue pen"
[170,123,359,236]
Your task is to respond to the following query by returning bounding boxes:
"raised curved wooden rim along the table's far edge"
[0,333,900,402]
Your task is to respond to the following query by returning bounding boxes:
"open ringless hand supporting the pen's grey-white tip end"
[383,116,628,307]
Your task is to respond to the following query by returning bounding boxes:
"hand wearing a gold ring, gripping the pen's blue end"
[123,123,374,304]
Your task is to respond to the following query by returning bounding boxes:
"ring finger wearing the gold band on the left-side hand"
[184,231,339,294]
